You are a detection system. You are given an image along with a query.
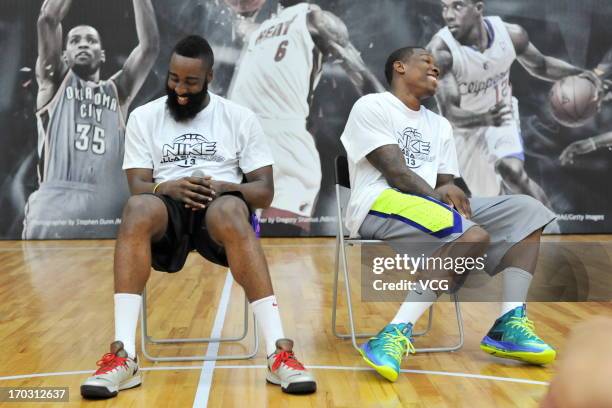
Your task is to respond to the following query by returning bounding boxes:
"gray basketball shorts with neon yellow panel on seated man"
[359,189,555,275]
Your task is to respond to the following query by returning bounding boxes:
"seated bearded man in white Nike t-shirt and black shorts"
[81,36,316,398]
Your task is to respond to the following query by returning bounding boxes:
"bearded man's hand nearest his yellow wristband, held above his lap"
[157,176,216,211]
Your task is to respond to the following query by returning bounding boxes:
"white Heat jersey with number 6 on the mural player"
[228,3,321,120]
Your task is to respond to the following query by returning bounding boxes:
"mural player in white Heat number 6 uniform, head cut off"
[226,0,384,231]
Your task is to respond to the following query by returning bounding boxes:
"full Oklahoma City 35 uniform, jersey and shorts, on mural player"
[23,70,129,239]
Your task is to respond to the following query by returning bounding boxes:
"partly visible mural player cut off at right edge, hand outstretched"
[559,48,612,166]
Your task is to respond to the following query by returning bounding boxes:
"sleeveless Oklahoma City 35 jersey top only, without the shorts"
[37,70,125,186]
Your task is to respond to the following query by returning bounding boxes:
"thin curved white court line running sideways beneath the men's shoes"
[0,364,548,391]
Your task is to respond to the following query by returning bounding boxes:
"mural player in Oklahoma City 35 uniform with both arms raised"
[23,0,159,239]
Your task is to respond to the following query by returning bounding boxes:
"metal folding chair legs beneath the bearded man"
[140,288,259,361]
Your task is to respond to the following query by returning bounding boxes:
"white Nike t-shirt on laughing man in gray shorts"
[340,92,459,237]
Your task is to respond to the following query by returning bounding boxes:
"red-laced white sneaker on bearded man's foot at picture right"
[266,339,317,394]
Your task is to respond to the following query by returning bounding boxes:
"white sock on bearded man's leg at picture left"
[115,293,142,358]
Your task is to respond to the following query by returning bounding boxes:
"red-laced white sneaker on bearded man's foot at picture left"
[81,341,142,399]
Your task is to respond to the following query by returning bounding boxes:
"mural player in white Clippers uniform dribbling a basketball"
[427,0,583,207]
